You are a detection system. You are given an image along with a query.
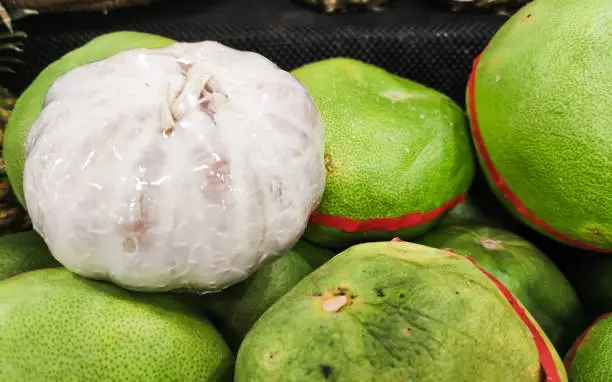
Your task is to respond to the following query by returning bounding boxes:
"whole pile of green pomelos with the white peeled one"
[0,0,612,382]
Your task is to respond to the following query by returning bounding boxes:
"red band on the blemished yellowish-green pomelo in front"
[444,248,561,382]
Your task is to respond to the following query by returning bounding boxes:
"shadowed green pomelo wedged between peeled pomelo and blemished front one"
[202,240,334,349]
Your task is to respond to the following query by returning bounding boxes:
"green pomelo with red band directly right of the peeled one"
[292,58,475,247]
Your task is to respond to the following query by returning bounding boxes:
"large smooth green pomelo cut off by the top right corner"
[471,0,612,249]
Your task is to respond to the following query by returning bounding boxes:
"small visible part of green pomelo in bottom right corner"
[565,314,612,382]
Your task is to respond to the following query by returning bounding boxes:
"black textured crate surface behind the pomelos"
[5,0,506,104]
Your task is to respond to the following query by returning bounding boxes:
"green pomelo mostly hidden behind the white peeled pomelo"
[3,32,176,206]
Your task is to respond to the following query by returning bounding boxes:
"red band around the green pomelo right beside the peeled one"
[310,194,465,232]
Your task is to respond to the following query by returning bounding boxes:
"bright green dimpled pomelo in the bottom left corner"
[0,268,233,382]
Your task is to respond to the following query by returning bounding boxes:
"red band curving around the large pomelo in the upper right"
[467,48,612,253]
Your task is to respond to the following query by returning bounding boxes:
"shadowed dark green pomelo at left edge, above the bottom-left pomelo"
[0,231,62,281]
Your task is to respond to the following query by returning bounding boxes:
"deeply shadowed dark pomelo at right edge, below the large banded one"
[570,256,612,316]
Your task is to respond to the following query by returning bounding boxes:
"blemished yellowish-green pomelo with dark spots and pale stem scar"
[235,241,566,382]
